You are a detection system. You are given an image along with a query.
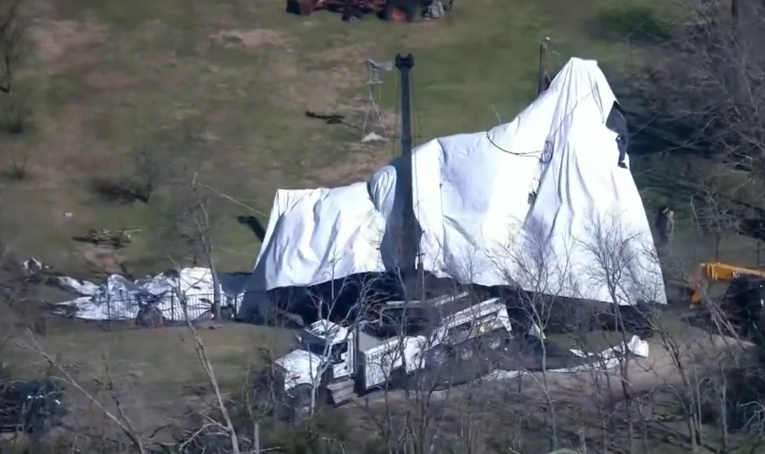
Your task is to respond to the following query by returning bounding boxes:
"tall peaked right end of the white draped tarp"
[514,61,666,304]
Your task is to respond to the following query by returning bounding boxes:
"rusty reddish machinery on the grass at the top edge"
[287,0,454,22]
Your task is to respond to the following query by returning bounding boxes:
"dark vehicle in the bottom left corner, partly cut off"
[0,379,66,437]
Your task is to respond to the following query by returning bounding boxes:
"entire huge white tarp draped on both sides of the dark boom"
[254,58,666,304]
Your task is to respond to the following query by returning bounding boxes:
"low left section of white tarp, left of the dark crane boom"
[254,183,385,290]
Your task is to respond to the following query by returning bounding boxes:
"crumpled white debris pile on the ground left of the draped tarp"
[57,268,241,321]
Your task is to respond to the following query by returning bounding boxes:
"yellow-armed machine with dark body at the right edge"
[691,262,765,344]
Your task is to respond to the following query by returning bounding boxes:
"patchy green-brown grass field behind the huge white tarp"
[0,0,676,280]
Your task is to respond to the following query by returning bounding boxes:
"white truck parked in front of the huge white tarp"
[275,292,512,417]
